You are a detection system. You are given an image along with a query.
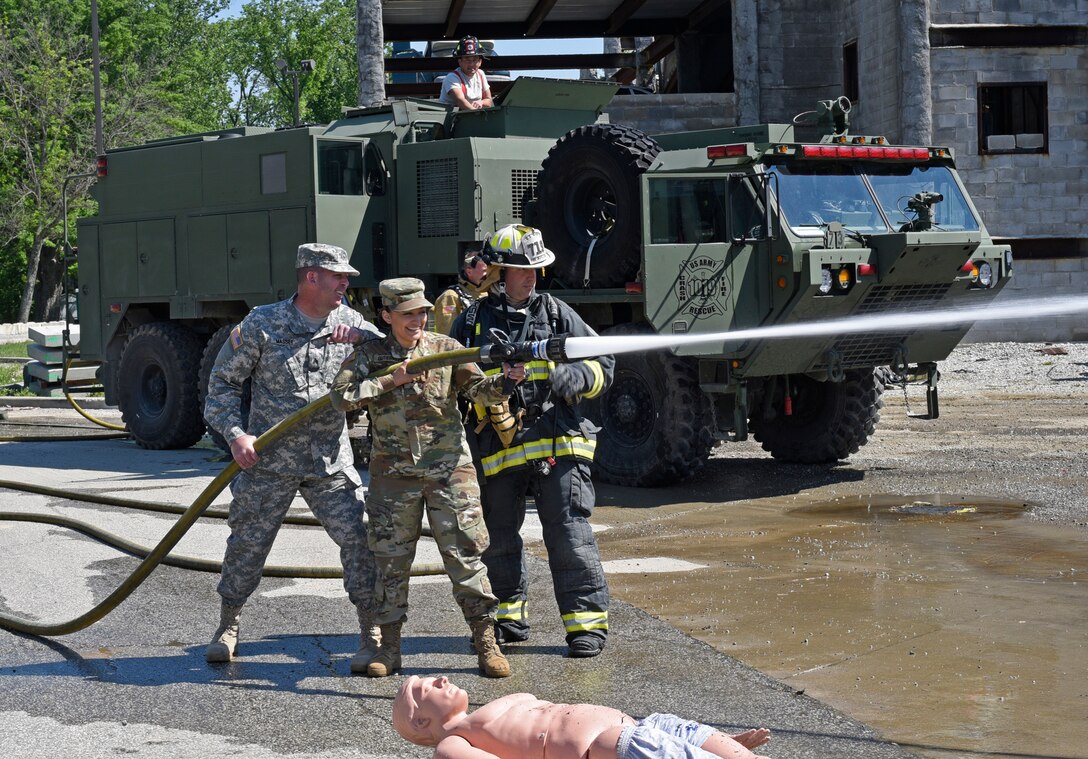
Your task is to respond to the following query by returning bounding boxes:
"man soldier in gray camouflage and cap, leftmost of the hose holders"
[205,242,381,672]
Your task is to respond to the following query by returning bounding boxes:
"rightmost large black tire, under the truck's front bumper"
[749,369,885,464]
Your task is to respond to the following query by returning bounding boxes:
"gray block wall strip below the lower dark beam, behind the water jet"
[964,258,1088,343]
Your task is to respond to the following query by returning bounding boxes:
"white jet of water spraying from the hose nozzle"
[564,296,1088,359]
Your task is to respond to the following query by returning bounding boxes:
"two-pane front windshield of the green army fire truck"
[767,162,978,236]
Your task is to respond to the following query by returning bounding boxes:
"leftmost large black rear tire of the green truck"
[118,322,205,450]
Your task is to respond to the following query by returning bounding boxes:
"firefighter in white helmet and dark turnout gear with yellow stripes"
[450,224,616,658]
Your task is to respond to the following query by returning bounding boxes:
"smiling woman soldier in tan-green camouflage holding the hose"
[332,277,524,677]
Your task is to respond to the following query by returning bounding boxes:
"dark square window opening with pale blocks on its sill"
[978,82,1047,153]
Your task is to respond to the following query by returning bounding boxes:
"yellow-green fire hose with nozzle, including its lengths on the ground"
[0,332,570,635]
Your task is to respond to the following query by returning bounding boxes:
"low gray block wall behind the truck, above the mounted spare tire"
[607,92,737,135]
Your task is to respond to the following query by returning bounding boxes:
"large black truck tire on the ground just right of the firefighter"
[584,324,714,487]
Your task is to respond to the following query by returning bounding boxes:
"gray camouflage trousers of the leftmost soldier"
[218,470,376,613]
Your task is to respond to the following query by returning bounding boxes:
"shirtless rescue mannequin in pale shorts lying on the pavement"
[393,675,770,759]
